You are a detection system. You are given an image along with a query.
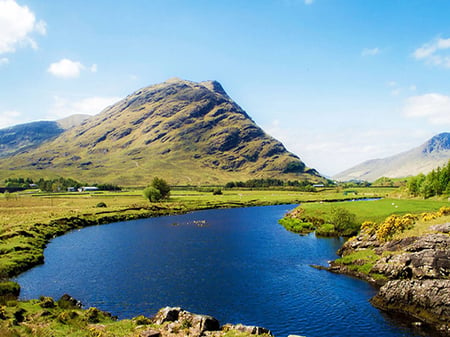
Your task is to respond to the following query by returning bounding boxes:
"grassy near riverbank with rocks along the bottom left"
[0,294,271,337]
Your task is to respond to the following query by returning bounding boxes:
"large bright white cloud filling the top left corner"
[0,0,47,54]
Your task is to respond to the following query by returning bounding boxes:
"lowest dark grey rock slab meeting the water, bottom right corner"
[371,279,450,333]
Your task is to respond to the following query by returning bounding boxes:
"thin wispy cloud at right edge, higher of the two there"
[413,38,450,68]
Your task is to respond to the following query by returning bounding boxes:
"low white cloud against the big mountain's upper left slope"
[47,96,121,120]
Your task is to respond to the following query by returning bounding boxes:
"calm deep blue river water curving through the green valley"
[17,205,432,337]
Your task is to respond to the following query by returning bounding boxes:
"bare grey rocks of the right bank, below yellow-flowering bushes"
[328,223,450,336]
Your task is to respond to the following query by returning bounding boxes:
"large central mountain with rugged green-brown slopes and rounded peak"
[0,79,322,186]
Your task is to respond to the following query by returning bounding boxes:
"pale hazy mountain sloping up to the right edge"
[333,132,450,181]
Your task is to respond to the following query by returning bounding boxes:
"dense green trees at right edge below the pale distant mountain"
[407,160,450,198]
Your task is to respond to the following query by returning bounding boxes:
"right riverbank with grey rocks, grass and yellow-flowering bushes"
[327,207,450,336]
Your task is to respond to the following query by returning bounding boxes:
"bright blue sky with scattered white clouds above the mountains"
[0,0,450,175]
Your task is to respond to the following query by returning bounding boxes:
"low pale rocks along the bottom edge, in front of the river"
[152,307,272,336]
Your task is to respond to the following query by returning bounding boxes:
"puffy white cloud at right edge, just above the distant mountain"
[403,93,450,125]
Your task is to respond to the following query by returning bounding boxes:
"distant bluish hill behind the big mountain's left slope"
[0,115,90,158]
